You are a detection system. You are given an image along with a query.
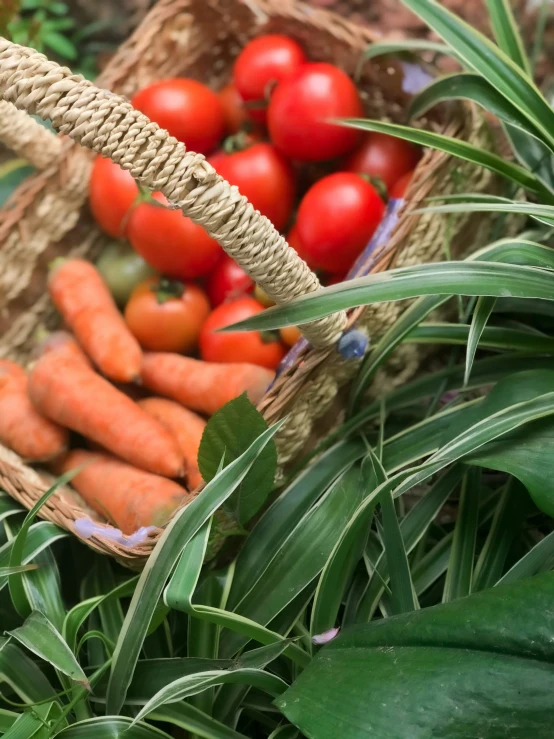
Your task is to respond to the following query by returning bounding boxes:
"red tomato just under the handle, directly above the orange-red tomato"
[127,193,223,280]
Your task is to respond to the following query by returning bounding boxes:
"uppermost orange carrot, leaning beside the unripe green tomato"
[48,259,142,382]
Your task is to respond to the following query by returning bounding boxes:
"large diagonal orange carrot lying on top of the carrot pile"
[29,352,184,477]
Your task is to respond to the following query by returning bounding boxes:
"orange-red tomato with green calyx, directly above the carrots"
[125,277,210,353]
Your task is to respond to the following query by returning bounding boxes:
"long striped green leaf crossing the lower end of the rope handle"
[224,260,554,331]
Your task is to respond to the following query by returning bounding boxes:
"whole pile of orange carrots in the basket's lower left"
[0,259,273,534]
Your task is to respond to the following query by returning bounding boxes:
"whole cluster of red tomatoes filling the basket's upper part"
[90,35,420,368]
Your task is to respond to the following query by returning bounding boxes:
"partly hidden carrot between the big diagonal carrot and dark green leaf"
[138,398,206,490]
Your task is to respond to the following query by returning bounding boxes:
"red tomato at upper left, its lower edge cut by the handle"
[131,77,225,154]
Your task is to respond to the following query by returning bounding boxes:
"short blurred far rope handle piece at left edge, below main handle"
[0,100,62,169]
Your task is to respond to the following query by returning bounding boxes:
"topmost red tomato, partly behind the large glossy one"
[233,34,306,123]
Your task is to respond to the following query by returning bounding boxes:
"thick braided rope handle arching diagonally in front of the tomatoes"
[0,37,347,348]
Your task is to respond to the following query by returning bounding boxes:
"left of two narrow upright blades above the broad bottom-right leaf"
[442,469,481,603]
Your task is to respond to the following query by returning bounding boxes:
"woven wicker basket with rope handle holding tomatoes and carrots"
[0,0,490,568]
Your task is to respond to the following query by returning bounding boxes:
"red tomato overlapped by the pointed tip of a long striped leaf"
[200,297,285,369]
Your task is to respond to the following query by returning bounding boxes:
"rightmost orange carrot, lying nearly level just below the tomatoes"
[141,352,274,415]
